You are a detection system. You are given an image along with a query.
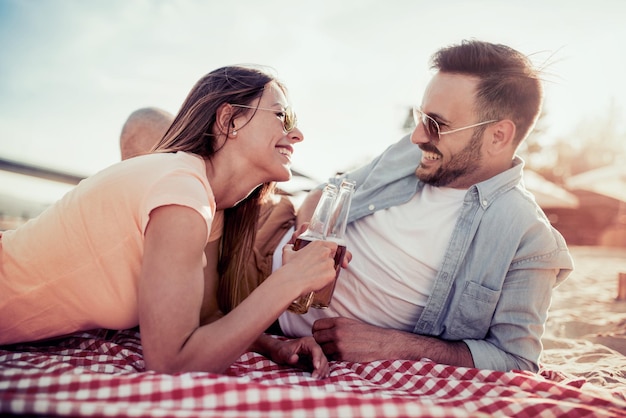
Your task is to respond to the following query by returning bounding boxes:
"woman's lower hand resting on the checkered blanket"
[269,337,330,379]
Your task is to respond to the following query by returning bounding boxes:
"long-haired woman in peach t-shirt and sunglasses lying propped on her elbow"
[0,67,336,376]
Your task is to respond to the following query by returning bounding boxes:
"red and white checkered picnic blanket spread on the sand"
[0,330,626,418]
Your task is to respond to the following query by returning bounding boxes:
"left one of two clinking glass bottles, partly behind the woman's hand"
[287,184,338,314]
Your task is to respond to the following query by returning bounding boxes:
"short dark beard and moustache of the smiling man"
[415,130,483,187]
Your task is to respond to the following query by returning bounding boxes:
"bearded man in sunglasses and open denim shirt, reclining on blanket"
[280,41,573,371]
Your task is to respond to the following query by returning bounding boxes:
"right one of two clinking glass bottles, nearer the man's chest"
[311,179,356,309]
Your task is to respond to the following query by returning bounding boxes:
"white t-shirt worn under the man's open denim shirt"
[279,185,466,336]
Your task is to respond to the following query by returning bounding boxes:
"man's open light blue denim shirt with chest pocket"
[330,136,573,372]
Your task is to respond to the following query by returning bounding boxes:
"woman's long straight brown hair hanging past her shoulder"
[154,66,286,313]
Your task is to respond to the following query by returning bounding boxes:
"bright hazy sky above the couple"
[0,0,626,207]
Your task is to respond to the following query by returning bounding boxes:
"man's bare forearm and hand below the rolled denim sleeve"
[313,317,474,367]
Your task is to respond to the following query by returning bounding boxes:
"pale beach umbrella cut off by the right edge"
[565,164,626,202]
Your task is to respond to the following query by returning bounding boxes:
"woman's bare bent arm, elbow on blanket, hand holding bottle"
[139,205,336,373]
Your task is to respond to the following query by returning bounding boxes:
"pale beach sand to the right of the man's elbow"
[541,247,626,393]
